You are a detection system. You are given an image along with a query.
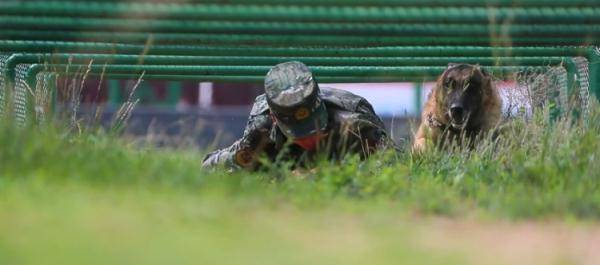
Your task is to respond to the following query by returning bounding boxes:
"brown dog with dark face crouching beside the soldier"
[412,64,502,152]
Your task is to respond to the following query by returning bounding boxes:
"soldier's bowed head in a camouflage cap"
[265,61,327,149]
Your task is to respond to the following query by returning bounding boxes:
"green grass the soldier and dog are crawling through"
[0,102,600,264]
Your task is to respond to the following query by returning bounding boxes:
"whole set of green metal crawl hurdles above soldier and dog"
[0,0,600,126]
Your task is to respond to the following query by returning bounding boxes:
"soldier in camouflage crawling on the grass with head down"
[203,61,393,169]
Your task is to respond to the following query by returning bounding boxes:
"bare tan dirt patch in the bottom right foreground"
[419,220,600,265]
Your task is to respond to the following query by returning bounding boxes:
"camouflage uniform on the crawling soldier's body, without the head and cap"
[203,88,394,169]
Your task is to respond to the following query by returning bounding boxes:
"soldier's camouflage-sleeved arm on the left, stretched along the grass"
[202,114,273,169]
